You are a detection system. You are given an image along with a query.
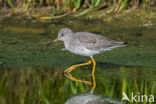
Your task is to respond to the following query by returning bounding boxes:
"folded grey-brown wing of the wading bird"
[74,32,122,50]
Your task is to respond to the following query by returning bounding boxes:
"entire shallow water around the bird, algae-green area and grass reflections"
[0,10,156,104]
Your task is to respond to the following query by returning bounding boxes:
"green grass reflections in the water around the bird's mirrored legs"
[0,66,156,104]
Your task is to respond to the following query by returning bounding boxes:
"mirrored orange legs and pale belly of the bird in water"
[65,73,124,104]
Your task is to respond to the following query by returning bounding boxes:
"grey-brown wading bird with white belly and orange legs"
[53,28,127,75]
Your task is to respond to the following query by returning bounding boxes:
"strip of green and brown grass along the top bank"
[0,0,155,18]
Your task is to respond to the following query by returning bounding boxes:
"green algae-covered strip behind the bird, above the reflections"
[0,11,156,68]
